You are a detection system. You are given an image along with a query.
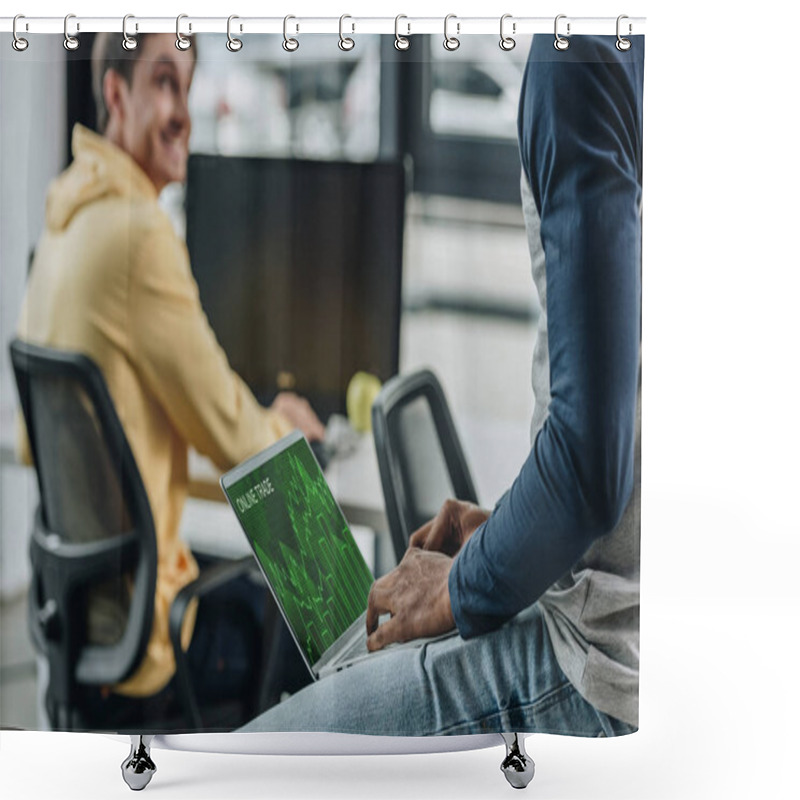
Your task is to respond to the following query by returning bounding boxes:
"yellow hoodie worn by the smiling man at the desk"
[19,125,291,696]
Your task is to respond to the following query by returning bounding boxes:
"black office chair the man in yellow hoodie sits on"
[10,339,262,733]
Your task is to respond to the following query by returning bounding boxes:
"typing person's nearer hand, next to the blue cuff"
[367,548,456,651]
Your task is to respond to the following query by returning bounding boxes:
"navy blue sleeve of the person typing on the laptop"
[449,36,644,638]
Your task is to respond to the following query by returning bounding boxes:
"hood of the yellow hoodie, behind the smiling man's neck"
[45,125,158,231]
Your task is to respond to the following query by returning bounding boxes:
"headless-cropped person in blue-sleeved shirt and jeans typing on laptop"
[242,36,644,736]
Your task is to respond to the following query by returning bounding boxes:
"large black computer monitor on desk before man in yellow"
[186,155,406,419]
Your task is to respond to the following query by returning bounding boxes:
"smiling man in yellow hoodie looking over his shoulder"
[18,33,324,720]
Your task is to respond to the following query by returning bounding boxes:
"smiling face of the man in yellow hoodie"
[114,34,195,192]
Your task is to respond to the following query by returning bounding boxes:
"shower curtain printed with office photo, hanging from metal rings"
[0,18,644,736]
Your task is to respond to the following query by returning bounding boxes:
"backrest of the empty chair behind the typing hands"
[372,369,478,561]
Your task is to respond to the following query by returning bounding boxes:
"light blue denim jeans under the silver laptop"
[234,605,636,736]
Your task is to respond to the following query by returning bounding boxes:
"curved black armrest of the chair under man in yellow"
[169,556,256,729]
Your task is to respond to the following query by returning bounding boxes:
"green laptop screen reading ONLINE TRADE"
[226,435,373,665]
